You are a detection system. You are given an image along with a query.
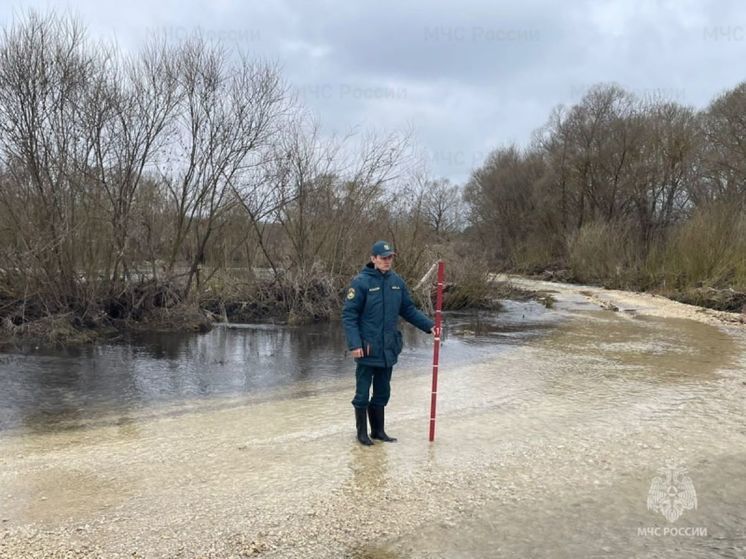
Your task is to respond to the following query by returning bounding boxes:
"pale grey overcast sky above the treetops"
[0,0,746,182]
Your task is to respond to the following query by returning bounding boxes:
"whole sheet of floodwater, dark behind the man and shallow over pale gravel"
[0,285,746,558]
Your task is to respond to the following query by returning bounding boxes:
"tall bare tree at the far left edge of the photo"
[0,12,97,308]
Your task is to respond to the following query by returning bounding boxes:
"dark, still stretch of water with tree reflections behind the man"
[0,303,557,431]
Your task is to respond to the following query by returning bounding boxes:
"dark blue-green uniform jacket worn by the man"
[342,262,435,367]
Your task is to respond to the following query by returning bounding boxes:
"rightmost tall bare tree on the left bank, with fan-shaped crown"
[160,37,286,295]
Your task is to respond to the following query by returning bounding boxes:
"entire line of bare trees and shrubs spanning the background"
[0,11,746,340]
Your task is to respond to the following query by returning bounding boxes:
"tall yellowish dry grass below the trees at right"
[514,206,746,312]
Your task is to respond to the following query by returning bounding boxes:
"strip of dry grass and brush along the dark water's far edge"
[0,266,552,349]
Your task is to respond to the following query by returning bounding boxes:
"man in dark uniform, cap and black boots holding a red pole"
[342,241,435,445]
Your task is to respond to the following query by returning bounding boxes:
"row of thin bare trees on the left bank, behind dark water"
[0,12,459,332]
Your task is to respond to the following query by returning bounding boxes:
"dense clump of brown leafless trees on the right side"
[465,82,746,296]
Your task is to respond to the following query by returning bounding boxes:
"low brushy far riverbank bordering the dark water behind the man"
[0,278,552,351]
